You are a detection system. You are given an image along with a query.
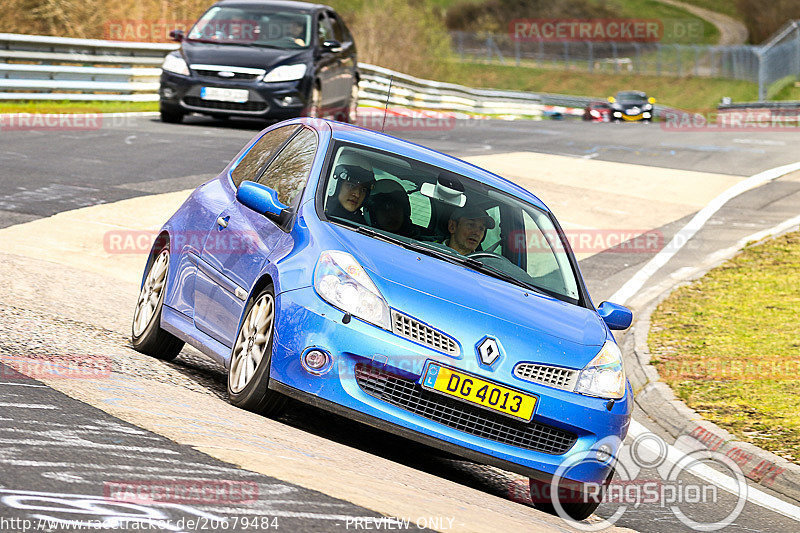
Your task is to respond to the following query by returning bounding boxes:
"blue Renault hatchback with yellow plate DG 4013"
[132,118,633,519]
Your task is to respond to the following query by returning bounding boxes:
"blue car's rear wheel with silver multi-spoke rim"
[131,245,183,361]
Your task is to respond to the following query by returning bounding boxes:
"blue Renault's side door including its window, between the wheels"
[194,125,317,346]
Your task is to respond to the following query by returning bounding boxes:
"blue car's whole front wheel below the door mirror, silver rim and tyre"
[228,285,286,415]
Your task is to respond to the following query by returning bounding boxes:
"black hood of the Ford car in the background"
[181,41,310,71]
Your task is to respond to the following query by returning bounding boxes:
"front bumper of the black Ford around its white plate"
[159,71,311,119]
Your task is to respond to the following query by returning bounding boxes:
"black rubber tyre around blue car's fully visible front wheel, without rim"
[228,285,287,416]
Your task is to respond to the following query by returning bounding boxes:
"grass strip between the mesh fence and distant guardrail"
[441,62,758,111]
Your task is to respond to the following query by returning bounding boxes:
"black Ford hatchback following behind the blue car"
[160,0,358,122]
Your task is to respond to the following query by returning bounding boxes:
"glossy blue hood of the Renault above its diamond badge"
[331,225,607,368]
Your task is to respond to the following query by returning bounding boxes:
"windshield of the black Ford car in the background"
[187,6,311,49]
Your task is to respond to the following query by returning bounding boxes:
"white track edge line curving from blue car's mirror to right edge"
[609,163,800,304]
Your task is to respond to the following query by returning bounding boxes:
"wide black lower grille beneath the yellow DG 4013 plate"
[355,363,578,455]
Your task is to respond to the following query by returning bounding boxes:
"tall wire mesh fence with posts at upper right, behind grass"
[451,21,800,100]
